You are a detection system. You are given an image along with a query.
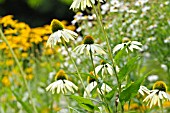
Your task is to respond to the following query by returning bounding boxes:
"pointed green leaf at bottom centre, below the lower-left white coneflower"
[70,95,99,111]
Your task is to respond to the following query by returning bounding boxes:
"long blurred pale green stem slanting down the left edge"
[0,29,38,113]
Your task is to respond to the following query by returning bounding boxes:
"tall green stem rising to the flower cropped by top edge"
[91,3,124,113]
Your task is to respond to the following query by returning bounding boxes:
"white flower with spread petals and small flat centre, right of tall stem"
[113,38,142,53]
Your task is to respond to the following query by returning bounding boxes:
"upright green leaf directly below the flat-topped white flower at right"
[118,56,139,82]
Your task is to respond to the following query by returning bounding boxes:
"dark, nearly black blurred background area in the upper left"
[0,0,74,27]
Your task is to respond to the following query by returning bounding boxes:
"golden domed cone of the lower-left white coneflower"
[55,70,68,80]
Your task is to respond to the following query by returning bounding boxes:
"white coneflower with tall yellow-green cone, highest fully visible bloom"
[46,19,78,47]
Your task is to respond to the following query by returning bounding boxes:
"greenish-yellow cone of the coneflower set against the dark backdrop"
[51,19,64,33]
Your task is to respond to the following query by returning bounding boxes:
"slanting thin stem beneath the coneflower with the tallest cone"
[62,40,88,95]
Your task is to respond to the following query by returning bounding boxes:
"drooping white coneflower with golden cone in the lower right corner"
[143,81,170,108]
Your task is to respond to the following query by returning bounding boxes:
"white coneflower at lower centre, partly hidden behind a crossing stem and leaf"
[84,72,112,97]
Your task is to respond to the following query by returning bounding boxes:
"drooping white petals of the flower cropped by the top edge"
[70,0,105,10]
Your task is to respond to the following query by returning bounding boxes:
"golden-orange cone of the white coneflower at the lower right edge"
[153,81,167,92]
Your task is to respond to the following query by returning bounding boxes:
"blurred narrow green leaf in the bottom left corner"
[12,91,32,113]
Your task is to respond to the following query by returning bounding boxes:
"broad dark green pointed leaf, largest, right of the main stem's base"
[119,73,149,103]
